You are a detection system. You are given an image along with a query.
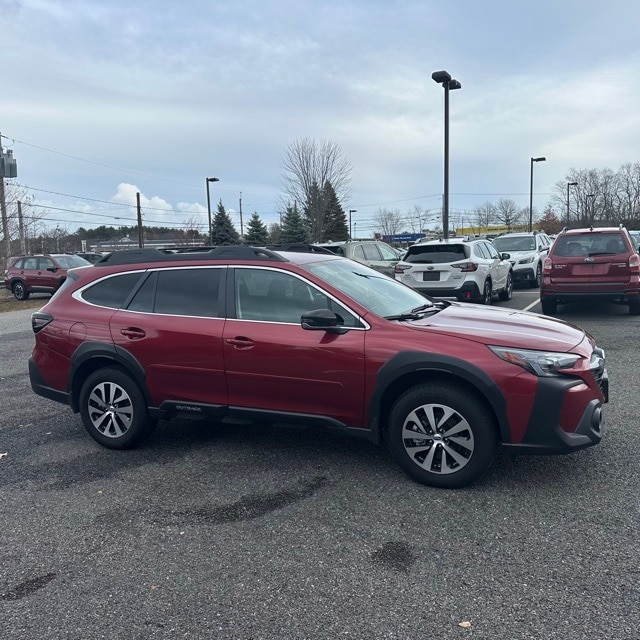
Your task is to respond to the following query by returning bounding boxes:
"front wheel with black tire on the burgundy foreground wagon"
[386,383,498,489]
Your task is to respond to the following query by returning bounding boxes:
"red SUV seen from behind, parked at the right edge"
[540,227,640,316]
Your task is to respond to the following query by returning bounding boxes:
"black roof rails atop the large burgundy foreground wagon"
[94,244,287,266]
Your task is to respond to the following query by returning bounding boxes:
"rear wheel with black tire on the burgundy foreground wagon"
[80,367,156,449]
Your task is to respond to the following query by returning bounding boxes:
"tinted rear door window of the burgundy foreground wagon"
[153,269,223,318]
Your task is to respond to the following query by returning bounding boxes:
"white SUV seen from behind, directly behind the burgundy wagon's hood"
[395,238,513,304]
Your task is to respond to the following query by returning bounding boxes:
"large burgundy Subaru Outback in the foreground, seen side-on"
[29,246,608,488]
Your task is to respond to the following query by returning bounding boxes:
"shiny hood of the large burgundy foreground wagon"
[410,302,587,352]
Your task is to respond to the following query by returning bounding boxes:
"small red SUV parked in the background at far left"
[4,253,90,300]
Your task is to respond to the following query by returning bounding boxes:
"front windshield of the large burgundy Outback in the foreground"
[304,260,432,317]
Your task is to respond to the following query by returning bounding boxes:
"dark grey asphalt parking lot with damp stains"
[0,289,640,640]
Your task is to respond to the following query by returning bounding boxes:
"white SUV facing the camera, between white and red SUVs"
[493,231,552,289]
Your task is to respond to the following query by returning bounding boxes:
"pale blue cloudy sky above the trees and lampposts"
[0,0,640,235]
